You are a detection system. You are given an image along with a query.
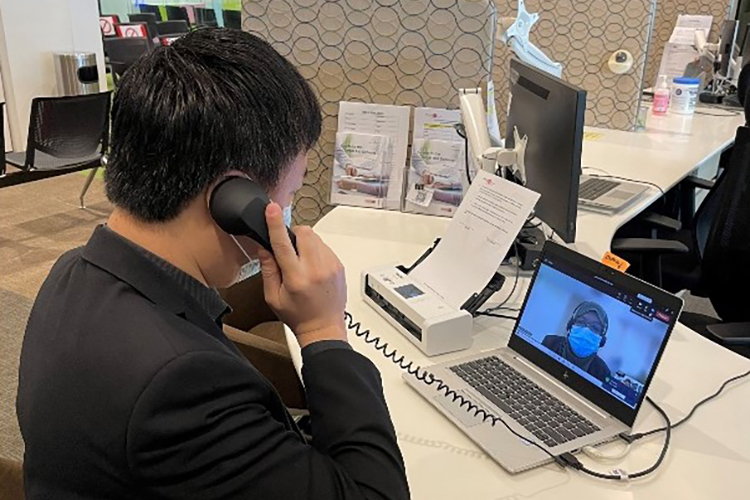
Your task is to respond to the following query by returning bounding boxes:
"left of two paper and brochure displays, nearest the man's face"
[331,101,410,210]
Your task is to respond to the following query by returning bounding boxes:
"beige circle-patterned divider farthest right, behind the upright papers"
[645,0,734,87]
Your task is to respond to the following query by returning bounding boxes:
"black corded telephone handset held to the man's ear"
[208,177,297,253]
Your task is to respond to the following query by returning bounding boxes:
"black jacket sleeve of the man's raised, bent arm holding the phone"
[127,349,409,500]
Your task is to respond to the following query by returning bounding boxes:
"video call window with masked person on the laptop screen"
[515,259,674,408]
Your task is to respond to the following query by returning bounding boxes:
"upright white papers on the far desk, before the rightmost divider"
[654,14,713,84]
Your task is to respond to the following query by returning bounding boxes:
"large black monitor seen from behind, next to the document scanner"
[505,59,586,243]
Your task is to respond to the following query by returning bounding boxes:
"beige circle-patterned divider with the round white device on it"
[493,0,656,135]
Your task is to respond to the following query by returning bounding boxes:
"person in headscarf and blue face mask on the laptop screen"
[542,302,611,382]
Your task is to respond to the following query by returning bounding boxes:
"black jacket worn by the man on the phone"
[18,228,409,500]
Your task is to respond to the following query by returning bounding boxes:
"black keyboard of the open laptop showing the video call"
[450,356,599,447]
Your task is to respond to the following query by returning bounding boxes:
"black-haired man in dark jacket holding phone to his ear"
[17,29,409,500]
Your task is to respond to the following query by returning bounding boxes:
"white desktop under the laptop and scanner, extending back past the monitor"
[287,112,750,500]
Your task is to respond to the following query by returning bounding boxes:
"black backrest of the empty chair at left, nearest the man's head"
[26,91,111,168]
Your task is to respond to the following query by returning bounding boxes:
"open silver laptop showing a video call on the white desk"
[404,241,682,473]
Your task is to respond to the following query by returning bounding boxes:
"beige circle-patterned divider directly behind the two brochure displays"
[242,0,496,224]
